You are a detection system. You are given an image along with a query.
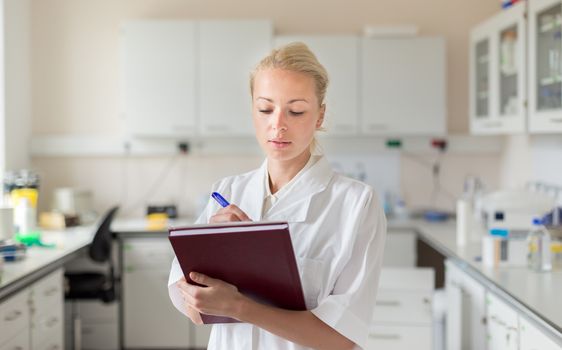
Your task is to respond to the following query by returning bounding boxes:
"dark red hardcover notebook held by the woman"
[168,222,306,324]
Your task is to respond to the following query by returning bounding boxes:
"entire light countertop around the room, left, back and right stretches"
[0,218,562,337]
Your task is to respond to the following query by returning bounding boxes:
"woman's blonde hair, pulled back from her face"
[250,42,329,153]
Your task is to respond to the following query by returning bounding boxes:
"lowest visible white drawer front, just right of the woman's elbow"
[365,325,431,350]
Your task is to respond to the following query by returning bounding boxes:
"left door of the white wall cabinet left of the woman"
[121,20,196,137]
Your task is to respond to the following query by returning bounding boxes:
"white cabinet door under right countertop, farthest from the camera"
[445,260,487,350]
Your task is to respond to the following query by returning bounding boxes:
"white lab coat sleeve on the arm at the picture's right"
[312,191,386,348]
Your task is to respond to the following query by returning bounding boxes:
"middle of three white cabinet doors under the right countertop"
[486,292,519,350]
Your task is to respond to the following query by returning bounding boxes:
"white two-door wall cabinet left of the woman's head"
[121,20,272,137]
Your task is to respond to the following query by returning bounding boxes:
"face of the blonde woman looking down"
[252,69,324,161]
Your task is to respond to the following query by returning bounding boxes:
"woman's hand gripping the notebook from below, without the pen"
[178,272,246,324]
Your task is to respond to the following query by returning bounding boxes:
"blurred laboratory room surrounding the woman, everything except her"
[0,0,562,350]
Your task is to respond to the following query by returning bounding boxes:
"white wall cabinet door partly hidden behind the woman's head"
[275,35,359,136]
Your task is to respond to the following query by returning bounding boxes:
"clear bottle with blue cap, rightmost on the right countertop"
[527,218,552,272]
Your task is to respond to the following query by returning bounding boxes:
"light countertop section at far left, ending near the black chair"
[0,225,96,300]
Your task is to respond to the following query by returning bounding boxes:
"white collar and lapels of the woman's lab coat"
[244,156,334,222]
